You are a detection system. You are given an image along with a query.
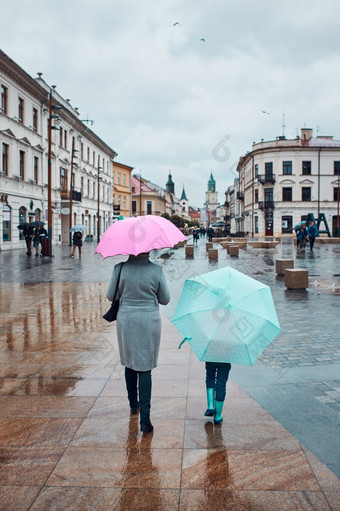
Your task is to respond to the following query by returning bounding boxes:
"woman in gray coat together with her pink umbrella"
[96,215,186,433]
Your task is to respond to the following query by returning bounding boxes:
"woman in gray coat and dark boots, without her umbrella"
[106,253,170,432]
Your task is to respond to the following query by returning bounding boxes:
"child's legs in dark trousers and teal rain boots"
[204,362,231,425]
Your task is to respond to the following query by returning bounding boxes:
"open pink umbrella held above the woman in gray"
[96,215,187,259]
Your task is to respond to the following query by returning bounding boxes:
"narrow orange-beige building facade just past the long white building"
[112,161,133,218]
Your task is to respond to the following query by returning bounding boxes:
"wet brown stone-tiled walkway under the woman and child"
[0,283,340,511]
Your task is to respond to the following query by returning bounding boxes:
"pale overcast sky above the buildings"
[0,0,340,207]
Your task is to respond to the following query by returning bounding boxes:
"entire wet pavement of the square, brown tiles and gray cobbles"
[0,240,340,511]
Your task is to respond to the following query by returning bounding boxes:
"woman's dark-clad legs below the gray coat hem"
[125,367,152,423]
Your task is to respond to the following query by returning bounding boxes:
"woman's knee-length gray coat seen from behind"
[106,255,170,371]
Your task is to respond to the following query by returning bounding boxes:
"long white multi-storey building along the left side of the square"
[0,51,116,250]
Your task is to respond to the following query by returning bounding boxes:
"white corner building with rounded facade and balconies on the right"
[236,128,340,236]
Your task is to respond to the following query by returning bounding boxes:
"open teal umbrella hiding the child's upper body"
[172,266,281,365]
